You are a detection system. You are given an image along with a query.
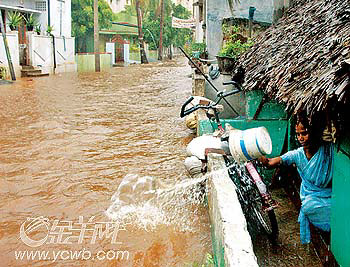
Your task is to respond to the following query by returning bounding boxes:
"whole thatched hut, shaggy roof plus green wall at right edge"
[233,0,350,266]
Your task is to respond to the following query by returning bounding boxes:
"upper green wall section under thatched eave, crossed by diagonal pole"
[246,90,287,120]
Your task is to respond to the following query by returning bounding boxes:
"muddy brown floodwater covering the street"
[0,59,211,266]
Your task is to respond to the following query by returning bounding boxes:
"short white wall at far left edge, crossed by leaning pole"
[0,32,21,79]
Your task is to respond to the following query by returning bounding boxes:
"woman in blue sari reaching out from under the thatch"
[259,113,334,244]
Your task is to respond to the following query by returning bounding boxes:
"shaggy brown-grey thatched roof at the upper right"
[239,0,350,113]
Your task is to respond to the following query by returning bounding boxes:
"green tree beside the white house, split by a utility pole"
[72,0,113,52]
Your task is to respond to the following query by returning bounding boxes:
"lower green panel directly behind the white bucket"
[199,119,288,157]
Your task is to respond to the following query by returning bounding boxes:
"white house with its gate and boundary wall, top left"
[0,0,76,76]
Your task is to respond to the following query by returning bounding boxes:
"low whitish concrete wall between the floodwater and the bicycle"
[207,154,258,267]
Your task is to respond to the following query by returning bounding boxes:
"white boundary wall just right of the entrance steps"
[28,32,76,73]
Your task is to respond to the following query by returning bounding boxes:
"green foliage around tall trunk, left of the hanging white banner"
[142,3,192,49]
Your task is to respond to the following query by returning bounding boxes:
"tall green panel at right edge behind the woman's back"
[331,138,350,267]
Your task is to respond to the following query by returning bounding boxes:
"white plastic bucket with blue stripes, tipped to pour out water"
[228,127,272,162]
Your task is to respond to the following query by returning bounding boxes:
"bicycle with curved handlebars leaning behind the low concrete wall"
[180,81,278,245]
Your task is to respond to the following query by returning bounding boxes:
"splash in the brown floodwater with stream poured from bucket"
[106,174,208,231]
